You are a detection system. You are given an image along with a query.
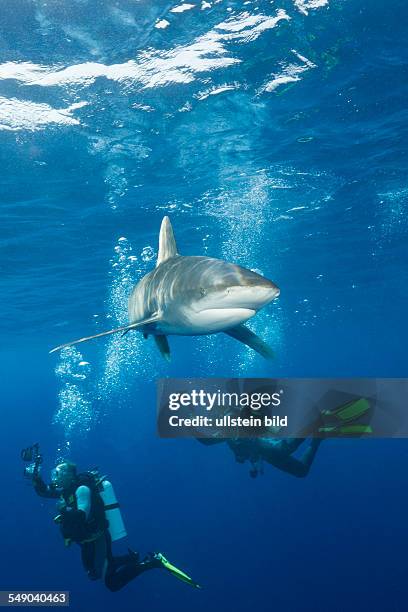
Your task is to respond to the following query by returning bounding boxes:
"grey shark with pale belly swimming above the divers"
[50,217,279,360]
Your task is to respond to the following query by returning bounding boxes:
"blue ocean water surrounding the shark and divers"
[0,0,408,612]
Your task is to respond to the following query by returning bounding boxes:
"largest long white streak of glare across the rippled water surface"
[0,9,290,94]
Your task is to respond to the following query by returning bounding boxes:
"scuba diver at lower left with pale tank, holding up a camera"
[21,444,201,591]
